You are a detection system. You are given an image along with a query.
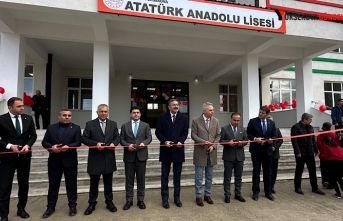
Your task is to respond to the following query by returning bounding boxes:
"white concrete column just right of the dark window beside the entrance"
[242,54,260,127]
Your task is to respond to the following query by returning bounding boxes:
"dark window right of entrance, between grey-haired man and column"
[219,85,238,112]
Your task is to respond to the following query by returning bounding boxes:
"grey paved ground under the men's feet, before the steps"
[9,179,343,221]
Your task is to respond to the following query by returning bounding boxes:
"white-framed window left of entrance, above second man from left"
[67,78,93,110]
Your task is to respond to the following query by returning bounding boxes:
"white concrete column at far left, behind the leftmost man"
[0,32,26,114]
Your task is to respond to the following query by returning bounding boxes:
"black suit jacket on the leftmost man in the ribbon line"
[0,113,37,161]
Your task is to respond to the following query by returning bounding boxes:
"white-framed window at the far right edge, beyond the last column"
[324,82,343,107]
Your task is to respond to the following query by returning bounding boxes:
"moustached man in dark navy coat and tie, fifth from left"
[155,99,189,209]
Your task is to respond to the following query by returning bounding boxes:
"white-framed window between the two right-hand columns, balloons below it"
[270,79,296,109]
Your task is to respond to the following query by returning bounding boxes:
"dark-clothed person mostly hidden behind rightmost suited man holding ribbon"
[267,115,283,194]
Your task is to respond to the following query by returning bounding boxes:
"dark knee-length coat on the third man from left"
[81,118,120,175]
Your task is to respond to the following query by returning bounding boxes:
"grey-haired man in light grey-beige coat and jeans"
[192,102,220,206]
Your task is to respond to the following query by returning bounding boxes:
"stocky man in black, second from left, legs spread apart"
[42,109,81,218]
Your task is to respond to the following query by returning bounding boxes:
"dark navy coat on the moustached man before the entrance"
[155,111,188,163]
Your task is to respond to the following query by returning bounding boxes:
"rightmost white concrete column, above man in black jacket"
[295,58,313,121]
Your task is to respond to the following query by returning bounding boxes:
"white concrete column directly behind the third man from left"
[92,42,110,119]
